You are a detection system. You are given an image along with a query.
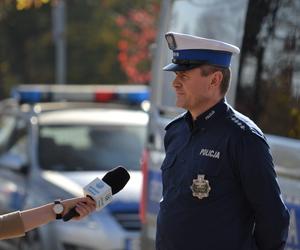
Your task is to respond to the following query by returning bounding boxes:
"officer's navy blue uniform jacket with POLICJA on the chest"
[156,100,289,250]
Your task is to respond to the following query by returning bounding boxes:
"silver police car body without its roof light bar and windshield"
[0,88,148,250]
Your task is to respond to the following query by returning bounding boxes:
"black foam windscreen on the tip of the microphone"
[102,166,130,194]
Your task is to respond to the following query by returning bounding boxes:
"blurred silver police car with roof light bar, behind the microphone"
[0,85,148,250]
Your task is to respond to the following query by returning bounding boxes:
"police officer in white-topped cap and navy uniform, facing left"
[156,32,289,250]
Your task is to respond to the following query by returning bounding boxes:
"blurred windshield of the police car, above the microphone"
[39,124,146,171]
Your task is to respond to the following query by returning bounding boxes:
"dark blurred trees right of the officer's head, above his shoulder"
[236,0,300,138]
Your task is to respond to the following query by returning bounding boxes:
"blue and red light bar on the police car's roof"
[12,85,149,104]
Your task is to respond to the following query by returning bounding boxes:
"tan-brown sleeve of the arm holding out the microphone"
[0,212,25,240]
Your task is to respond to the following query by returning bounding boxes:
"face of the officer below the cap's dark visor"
[173,68,216,113]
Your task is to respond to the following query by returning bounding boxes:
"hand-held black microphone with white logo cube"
[63,166,130,221]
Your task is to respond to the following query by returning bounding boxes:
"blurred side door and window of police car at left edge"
[0,114,29,213]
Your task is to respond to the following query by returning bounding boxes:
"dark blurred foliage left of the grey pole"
[0,1,53,98]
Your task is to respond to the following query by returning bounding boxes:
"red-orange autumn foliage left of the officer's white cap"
[116,4,159,84]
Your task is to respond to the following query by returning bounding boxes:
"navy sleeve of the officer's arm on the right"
[236,132,289,250]
